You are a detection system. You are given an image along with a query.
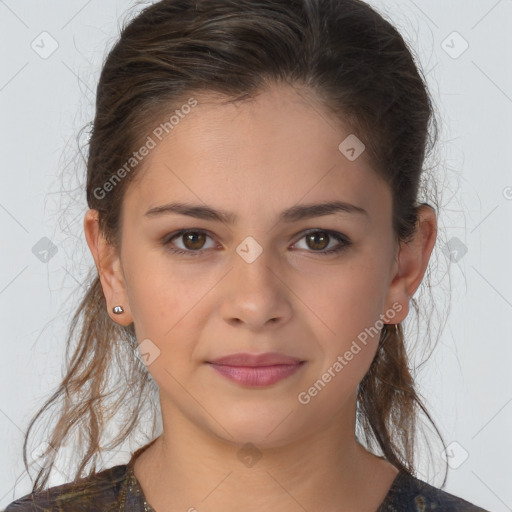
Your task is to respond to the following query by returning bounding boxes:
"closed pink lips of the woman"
[208,352,305,386]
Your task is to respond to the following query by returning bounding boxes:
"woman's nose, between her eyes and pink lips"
[221,241,293,331]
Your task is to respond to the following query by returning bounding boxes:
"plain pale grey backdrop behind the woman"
[0,0,512,511]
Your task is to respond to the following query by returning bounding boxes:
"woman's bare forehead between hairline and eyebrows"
[123,86,391,223]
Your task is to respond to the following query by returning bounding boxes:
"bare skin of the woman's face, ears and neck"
[84,85,437,511]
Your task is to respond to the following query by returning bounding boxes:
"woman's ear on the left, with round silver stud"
[84,209,133,325]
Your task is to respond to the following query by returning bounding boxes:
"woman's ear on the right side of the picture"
[386,204,437,323]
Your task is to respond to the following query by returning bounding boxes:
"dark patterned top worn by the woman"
[5,443,489,512]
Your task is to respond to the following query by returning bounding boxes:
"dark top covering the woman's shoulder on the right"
[378,472,489,512]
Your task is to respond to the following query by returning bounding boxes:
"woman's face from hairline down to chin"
[87,86,424,447]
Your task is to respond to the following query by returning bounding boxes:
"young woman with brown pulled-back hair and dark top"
[7,0,492,512]
